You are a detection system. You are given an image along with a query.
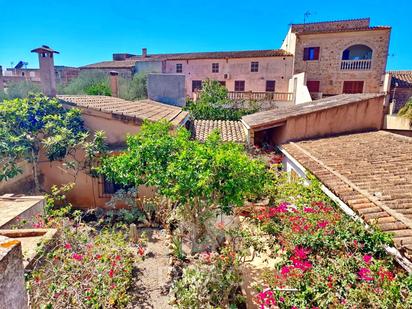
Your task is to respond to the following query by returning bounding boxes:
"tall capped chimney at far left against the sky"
[31,45,59,97]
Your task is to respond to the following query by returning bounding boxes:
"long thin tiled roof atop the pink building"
[82,49,293,69]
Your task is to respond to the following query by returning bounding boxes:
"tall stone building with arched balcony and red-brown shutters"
[281,18,391,97]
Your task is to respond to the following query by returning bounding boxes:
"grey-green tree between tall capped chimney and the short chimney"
[57,70,111,95]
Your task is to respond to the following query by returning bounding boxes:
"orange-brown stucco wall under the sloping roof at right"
[254,97,384,145]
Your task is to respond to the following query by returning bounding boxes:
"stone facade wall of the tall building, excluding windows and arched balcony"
[294,29,390,95]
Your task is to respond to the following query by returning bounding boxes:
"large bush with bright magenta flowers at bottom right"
[251,174,412,308]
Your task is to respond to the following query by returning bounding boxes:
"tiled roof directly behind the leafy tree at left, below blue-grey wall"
[57,95,188,125]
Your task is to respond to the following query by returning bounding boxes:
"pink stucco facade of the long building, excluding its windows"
[165,56,293,97]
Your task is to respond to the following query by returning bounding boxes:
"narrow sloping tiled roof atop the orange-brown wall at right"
[242,93,383,129]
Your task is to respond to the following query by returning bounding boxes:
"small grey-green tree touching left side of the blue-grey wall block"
[119,73,147,100]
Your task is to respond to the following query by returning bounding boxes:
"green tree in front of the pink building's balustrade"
[187,79,257,120]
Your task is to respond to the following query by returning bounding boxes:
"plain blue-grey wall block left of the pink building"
[147,73,186,106]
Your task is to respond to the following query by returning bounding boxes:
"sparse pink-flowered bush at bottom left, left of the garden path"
[28,226,133,308]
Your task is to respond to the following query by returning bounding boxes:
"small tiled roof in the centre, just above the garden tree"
[191,120,246,143]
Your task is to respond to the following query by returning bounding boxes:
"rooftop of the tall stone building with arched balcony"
[291,18,391,34]
